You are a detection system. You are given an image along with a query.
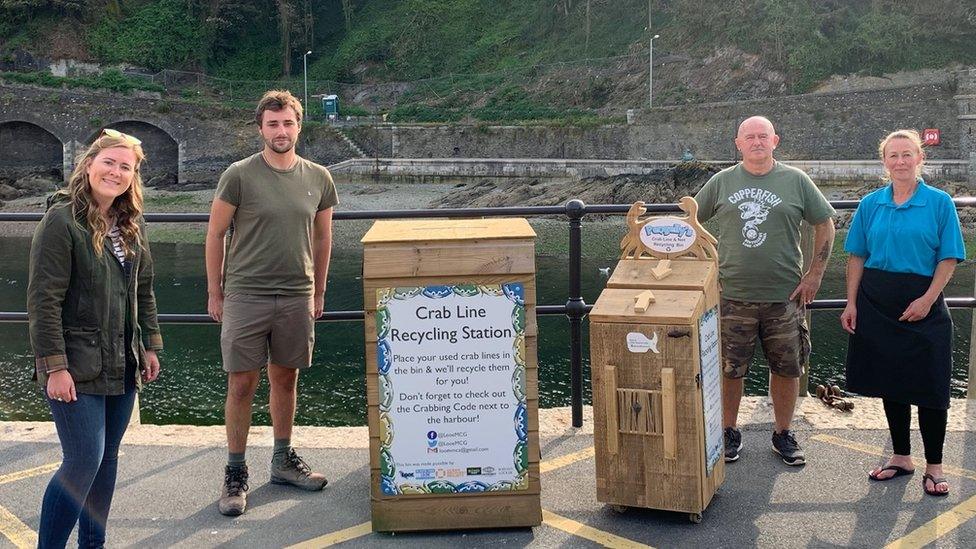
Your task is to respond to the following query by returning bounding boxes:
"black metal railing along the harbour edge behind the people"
[0,197,976,427]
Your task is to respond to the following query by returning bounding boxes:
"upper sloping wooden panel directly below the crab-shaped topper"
[607,259,718,291]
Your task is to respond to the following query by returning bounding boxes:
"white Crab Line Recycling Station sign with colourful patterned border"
[376,283,528,495]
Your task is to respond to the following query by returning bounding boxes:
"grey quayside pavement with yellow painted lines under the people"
[0,398,976,548]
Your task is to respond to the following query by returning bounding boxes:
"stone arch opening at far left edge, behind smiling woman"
[0,119,65,199]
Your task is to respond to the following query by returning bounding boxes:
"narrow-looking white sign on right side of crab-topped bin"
[698,307,724,475]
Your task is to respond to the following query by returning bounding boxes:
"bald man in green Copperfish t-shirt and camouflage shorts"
[695,116,834,465]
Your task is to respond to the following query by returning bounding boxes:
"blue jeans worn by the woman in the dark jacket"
[37,384,136,548]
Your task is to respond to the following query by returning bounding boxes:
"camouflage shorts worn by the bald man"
[722,299,810,379]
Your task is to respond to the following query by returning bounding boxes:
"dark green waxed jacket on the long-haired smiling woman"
[27,197,163,395]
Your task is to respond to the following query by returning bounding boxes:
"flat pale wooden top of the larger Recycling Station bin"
[362,218,535,244]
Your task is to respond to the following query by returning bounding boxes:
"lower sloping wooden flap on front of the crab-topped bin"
[590,288,705,324]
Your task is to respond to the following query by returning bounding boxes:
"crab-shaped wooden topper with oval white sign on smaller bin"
[620,196,718,261]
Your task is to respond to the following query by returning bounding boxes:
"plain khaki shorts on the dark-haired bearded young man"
[220,293,315,372]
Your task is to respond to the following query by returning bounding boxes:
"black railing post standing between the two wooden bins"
[566,200,586,427]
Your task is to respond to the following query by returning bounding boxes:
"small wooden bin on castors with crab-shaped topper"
[589,197,725,522]
